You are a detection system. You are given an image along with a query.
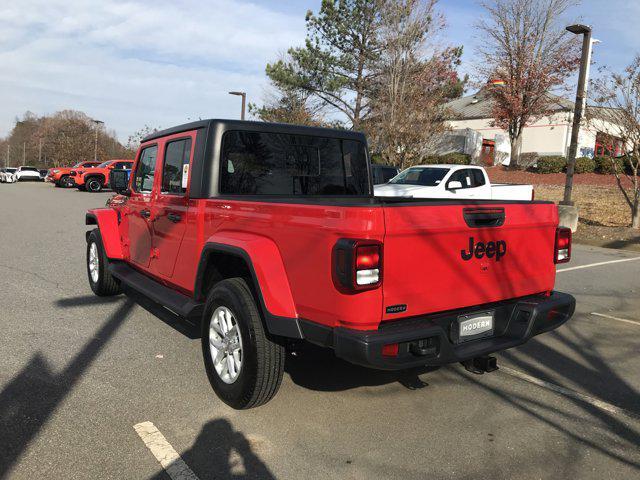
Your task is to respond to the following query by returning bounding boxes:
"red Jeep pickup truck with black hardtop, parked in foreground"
[86,120,575,409]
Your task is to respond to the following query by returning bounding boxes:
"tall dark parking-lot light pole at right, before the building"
[560,25,592,204]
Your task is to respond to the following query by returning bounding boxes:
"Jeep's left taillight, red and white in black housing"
[332,238,382,293]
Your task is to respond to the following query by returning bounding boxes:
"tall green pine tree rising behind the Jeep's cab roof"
[266,0,380,130]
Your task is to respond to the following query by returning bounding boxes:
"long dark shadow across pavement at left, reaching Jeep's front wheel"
[0,296,133,478]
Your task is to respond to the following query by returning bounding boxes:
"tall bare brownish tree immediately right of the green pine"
[365,0,462,168]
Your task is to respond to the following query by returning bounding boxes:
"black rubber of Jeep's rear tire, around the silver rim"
[202,278,285,410]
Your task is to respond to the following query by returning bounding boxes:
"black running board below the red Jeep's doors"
[109,262,204,318]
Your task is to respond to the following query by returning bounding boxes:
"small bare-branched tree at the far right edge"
[588,55,640,229]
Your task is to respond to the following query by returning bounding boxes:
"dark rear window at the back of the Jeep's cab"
[220,131,370,195]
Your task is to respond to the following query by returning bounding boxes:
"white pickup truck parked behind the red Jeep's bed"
[374,165,534,200]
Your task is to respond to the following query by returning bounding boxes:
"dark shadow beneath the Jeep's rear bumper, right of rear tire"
[284,344,437,392]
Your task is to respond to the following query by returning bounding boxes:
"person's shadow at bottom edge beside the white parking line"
[151,419,275,480]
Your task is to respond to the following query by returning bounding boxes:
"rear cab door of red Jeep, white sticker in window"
[151,132,196,278]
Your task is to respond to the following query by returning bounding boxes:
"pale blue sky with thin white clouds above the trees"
[0,0,640,141]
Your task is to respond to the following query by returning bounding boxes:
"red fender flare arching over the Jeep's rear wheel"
[194,232,304,339]
